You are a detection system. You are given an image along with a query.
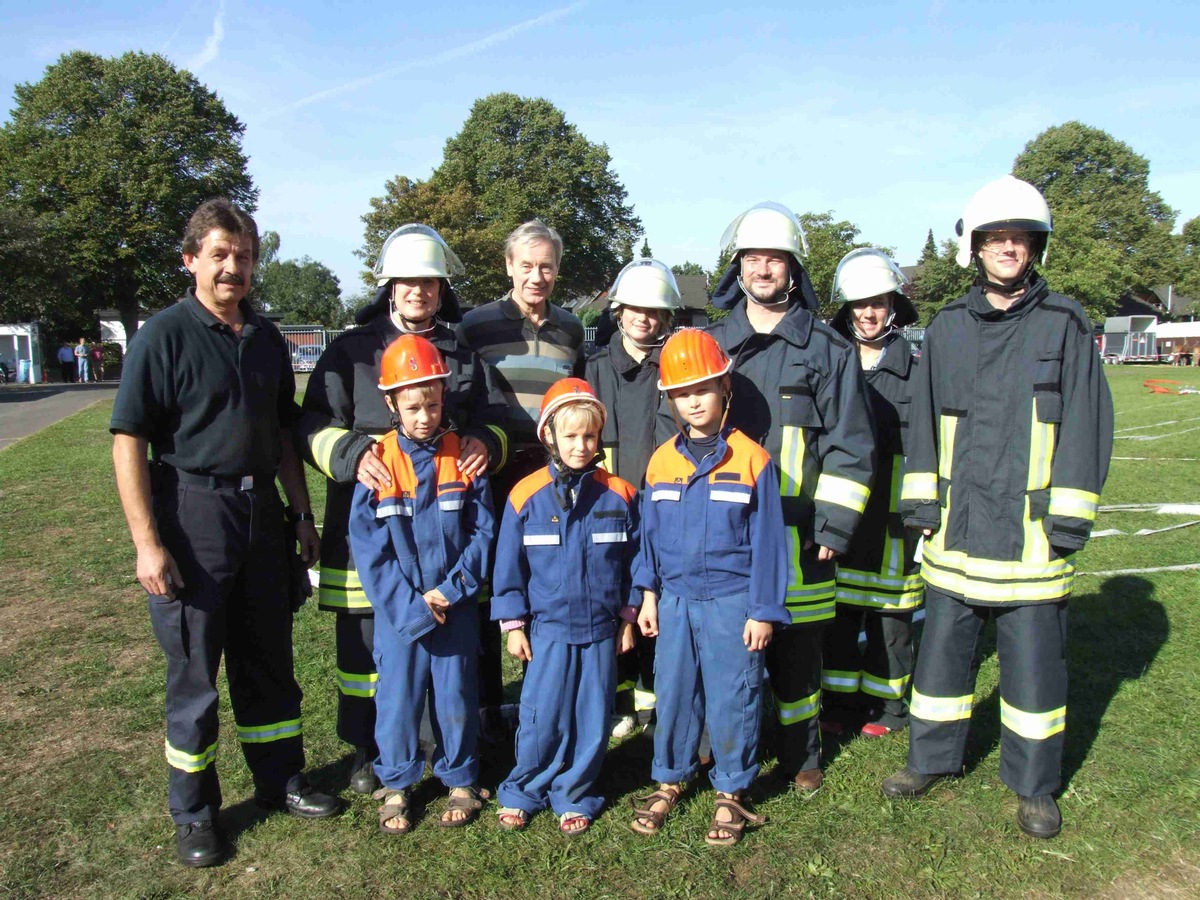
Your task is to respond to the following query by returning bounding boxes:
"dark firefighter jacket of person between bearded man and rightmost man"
[838,335,924,612]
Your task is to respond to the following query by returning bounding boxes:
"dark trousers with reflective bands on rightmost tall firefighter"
[908,589,1067,797]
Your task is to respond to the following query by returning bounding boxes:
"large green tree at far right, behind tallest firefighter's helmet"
[1013,121,1178,318]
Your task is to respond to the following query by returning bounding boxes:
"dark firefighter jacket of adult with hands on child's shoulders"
[296,307,506,613]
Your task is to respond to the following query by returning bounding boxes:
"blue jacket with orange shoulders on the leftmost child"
[349,432,494,642]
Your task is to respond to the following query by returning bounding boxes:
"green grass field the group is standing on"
[0,366,1200,898]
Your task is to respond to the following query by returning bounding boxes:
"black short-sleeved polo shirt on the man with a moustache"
[108,288,299,478]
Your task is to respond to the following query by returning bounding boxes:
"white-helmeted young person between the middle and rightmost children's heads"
[584,259,679,738]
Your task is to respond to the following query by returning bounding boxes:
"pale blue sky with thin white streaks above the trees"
[0,0,1200,303]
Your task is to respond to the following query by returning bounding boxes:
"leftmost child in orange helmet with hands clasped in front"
[349,335,494,834]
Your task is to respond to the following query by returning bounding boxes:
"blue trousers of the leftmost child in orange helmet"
[374,602,479,788]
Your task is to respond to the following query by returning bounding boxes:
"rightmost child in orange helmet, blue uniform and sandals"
[631,329,791,846]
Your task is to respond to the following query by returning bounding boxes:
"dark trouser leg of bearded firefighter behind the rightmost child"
[767,622,824,778]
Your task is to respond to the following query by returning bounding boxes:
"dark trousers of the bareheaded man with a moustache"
[148,479,304,824]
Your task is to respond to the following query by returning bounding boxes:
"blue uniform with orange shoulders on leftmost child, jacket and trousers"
[349,432,496,788]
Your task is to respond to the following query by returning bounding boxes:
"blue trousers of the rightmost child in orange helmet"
[650,589,764,793]
